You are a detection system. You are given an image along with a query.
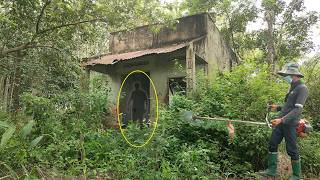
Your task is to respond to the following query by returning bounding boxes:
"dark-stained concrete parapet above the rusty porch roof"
[110,14,207,54]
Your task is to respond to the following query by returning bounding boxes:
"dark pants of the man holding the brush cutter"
[269,124,299,160]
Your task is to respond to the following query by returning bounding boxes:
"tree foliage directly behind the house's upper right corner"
[182,0,257,63]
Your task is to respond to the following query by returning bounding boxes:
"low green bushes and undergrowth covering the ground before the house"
[0,62,320,179]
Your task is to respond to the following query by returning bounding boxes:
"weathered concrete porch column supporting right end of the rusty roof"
[186,43,196,96]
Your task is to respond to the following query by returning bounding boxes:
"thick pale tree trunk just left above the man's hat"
[265,10,276,72]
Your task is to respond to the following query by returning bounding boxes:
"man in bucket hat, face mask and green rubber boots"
[260,63,308,180]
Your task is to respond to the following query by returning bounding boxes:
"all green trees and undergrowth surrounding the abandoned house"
[0,0,320,179]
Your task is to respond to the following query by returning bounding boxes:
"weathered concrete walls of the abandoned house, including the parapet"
[97,14,231,104]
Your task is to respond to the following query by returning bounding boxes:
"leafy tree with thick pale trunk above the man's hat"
[258,0,319,69]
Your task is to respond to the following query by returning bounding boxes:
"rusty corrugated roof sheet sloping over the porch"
[86,42,190,66]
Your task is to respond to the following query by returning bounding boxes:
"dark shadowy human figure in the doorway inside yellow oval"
[129,83,148,128]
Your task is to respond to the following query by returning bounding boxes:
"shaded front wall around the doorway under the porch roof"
[106,48,186,103]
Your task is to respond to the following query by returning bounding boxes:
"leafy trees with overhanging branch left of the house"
[0,0,176,111]
